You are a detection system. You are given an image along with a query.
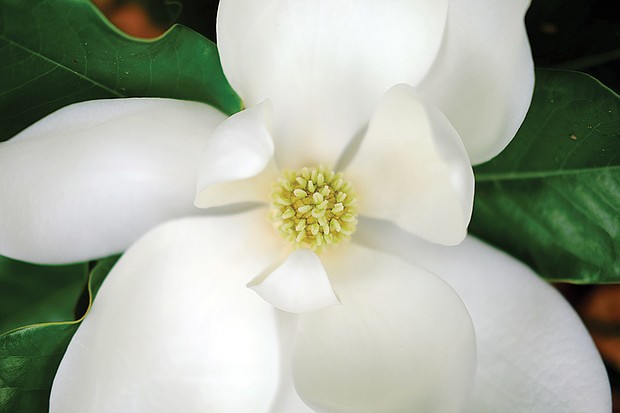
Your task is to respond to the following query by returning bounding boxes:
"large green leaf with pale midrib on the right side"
[470,70,620,283]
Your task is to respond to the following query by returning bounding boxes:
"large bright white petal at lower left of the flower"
[51,210,291,413]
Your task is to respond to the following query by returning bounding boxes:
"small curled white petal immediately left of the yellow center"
[195,101,277,208]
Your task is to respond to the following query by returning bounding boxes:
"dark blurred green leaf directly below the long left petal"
[0,256,88,333]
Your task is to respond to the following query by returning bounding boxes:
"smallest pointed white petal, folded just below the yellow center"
[248,249,340,313]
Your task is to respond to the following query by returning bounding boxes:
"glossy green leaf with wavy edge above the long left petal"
[0,0,241,141]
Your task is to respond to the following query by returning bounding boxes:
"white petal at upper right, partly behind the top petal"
[418,0,534,164]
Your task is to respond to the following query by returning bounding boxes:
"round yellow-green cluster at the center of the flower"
[271,166,357,251]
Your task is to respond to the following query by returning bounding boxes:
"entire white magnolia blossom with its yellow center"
[0,0,609,413]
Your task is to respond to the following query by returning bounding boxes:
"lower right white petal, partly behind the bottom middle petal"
[356,220,611,413]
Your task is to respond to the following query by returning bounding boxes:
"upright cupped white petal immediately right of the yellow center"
[346,84,474,245]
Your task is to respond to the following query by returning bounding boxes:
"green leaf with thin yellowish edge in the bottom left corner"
[0,257,118,413]
